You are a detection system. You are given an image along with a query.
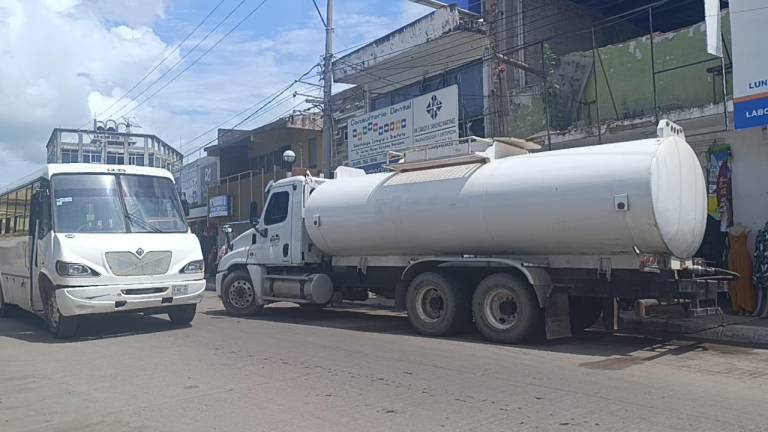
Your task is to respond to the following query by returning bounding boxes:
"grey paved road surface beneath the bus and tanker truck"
[0,294,768,432]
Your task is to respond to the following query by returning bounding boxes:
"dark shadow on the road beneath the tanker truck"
[203,305,707,362]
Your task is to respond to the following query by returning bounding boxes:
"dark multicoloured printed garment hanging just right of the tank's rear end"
[707,144,733,232]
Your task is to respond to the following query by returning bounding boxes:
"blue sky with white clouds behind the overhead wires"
[0,0,430,184]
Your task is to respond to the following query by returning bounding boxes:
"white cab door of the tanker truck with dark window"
[261,185,294,264]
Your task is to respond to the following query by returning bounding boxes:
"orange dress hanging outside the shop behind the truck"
[728,224,756,314]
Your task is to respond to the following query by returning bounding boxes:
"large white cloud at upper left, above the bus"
[0,0,167,184]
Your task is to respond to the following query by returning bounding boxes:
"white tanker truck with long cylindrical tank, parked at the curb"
[216,120,725,343]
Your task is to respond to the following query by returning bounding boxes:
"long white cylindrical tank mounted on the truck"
[305,121,707,258]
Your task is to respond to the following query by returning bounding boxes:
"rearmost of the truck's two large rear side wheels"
[472,273,541,343]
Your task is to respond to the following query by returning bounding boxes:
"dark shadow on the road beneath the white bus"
[0,310,186,344]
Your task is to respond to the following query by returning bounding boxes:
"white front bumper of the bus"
[56,279,205,316]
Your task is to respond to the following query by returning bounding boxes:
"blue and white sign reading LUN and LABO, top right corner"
[729,0,768,130]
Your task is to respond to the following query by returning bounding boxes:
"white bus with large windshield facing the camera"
[0,164,205,338]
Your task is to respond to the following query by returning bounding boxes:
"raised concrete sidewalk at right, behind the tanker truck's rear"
[621,307,768,347]
